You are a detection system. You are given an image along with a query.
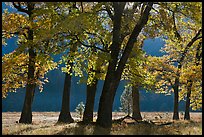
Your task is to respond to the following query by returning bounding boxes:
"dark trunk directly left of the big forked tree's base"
[83,78,98,123]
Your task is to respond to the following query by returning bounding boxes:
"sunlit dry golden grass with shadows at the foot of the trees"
[2,112,202,135]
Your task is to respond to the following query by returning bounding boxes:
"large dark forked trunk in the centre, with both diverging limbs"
[96,3,153,128]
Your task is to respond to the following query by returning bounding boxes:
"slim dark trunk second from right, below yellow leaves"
[173,77,179,120]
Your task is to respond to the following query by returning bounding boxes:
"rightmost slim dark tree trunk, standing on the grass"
[184,80,193,120]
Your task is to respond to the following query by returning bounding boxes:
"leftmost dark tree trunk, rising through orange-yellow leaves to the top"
[19,2,36,124]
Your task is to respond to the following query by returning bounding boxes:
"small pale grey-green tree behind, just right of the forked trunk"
[119,86,133,116]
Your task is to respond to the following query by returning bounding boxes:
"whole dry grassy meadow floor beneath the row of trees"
[2,112,202,135]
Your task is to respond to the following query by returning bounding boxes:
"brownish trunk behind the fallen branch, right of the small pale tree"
[132,86,142,120]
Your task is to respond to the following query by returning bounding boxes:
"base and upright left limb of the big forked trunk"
[96,2,125,127]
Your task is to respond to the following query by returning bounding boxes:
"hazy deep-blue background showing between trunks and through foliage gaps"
[2,3,196,112]
